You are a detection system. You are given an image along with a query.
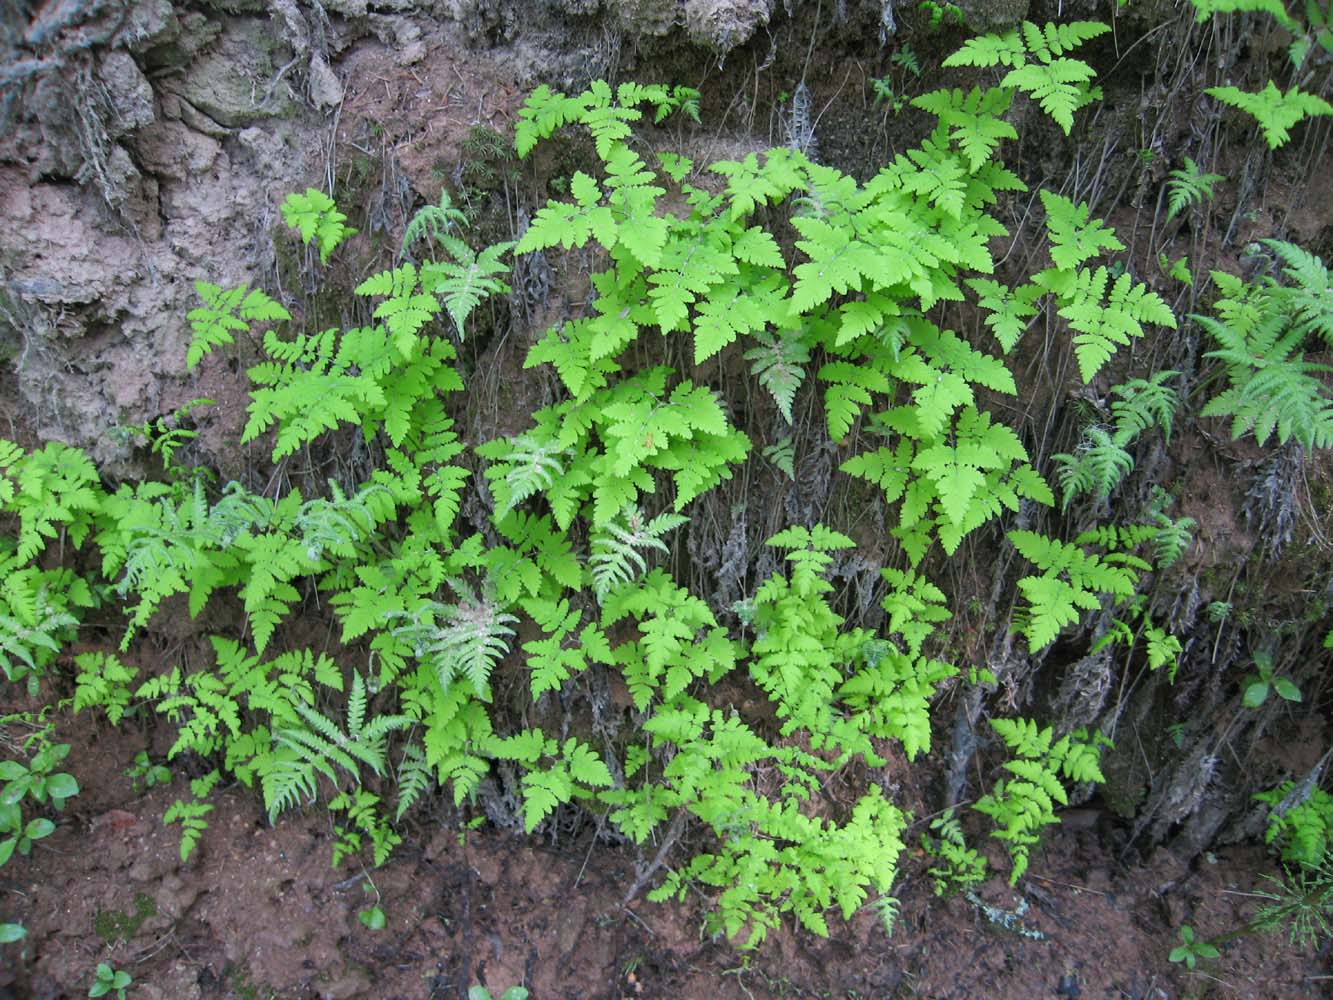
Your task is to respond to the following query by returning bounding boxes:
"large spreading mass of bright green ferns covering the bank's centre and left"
[0,24,1301,944]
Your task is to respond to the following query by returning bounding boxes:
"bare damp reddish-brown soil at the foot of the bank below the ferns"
[0,698,1333,1000]
